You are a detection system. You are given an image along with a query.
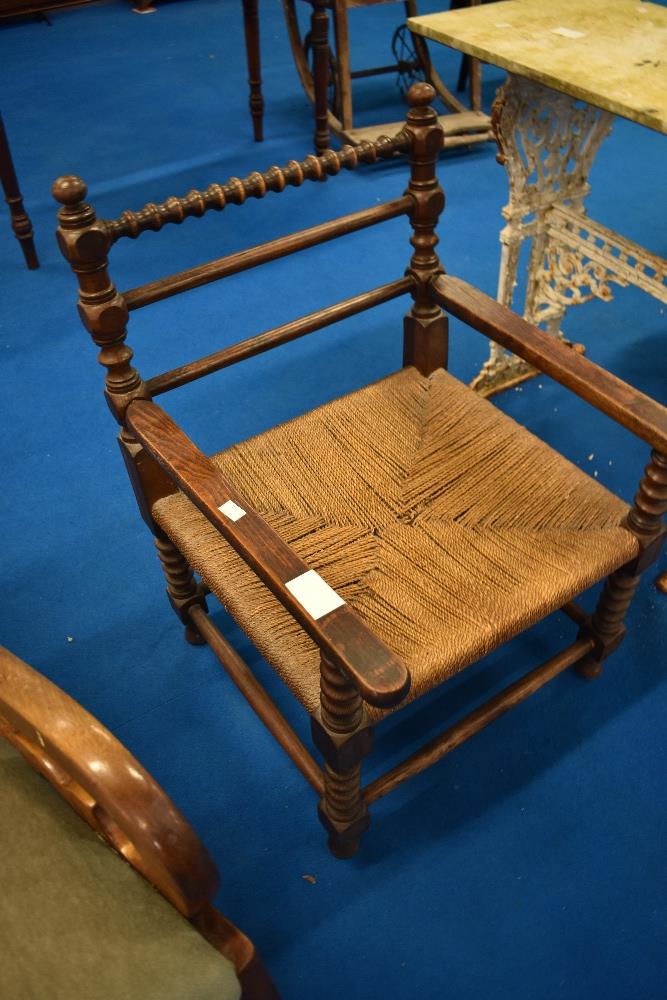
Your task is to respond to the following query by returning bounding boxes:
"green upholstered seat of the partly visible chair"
[0,738,241,1000]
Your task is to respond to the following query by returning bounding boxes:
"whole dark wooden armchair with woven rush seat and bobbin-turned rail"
[54,84,667,857]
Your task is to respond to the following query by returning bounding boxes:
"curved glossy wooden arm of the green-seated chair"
[0,646,220,919]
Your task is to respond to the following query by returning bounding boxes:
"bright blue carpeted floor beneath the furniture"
[0,0,667,1000]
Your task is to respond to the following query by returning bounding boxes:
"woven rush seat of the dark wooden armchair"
[153,368,638,718]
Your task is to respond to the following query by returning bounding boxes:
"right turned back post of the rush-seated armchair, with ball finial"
[403,83,448,375]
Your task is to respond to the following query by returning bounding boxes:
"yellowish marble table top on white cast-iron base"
[408,0,667,134]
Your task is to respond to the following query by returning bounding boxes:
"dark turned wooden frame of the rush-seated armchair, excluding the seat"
[54,84,667,857]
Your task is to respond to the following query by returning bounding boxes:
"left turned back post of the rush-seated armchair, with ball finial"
[53,175,150,425]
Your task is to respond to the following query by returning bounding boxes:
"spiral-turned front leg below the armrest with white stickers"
[312,656,373,858]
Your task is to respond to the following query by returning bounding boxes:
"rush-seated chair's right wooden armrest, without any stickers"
[431,274,667,455]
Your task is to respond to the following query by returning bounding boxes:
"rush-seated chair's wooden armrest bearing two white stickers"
[125,399,410,706]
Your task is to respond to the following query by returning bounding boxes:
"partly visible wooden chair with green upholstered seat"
[0,646,278,1000]
